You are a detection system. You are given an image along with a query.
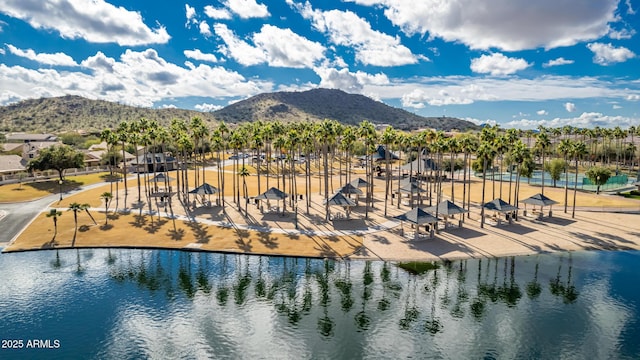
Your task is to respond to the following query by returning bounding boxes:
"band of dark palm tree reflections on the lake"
[56,249,579,339]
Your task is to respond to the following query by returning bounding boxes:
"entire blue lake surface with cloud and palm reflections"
[0,249,640,359]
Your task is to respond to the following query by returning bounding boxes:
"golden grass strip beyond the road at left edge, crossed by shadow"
[0,173,109,202]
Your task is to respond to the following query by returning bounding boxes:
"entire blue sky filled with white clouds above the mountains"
[0,0,640,129]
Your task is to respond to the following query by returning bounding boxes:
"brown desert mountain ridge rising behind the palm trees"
[0,89,479,133]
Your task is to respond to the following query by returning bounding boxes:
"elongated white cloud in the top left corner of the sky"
[0,0,171,46]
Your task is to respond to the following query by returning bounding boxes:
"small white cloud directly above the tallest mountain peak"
[313,67,389,96]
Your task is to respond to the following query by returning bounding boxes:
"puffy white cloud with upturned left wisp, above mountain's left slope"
[214,24,325,68]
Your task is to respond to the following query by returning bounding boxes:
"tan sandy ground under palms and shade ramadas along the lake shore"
[4,167,640,261]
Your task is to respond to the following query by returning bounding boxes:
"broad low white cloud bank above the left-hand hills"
[0,49,273,107]
